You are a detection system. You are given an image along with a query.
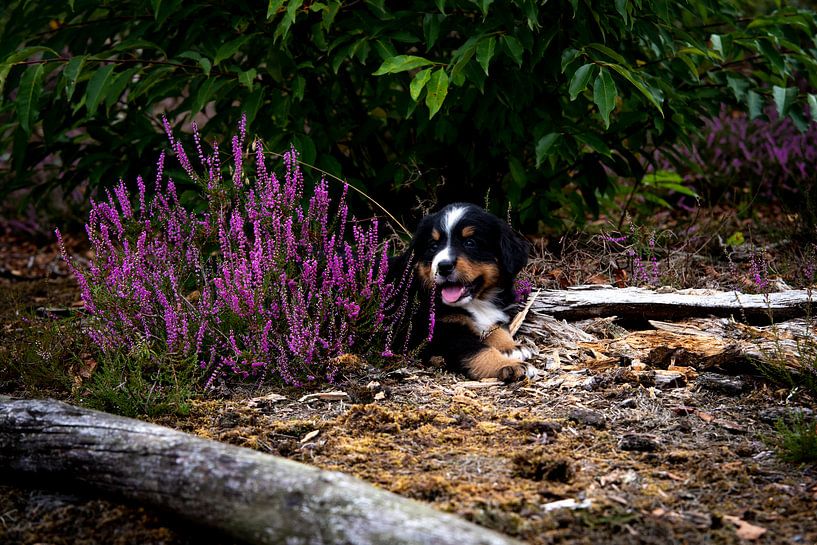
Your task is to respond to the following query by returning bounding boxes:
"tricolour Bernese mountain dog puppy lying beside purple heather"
[389,203,535,381]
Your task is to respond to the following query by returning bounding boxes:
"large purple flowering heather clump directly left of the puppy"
[57,119,392,386]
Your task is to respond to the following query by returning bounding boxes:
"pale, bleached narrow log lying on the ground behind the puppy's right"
[532,286,812,323]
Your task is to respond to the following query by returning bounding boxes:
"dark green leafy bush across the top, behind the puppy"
[0,0,817,227]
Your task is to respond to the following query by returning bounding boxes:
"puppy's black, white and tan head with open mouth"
[412,203,528,307]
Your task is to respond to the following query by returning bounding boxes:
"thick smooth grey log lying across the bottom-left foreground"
[0,397,516,545]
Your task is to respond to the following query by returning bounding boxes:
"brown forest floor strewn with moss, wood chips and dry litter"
[0,204,817,545]
